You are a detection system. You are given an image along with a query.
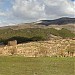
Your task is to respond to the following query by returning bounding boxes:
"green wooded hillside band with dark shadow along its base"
[0,28,75,44]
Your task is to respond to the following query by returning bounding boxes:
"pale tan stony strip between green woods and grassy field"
[0,39,75,57]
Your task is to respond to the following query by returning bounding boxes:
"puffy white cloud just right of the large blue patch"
[12,0,45,20]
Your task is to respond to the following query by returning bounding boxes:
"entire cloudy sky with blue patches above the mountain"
[0,0,75,27]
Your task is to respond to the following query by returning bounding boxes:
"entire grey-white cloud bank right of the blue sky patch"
[12,0,75,20]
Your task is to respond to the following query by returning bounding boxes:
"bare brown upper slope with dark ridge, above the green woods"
[0,17,75,33]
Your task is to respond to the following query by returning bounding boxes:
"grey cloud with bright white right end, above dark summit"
[44,0,75,18]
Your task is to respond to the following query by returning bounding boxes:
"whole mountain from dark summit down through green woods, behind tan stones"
[0,17,75,44]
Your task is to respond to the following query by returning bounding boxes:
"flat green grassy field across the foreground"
[0,56,75,75]
